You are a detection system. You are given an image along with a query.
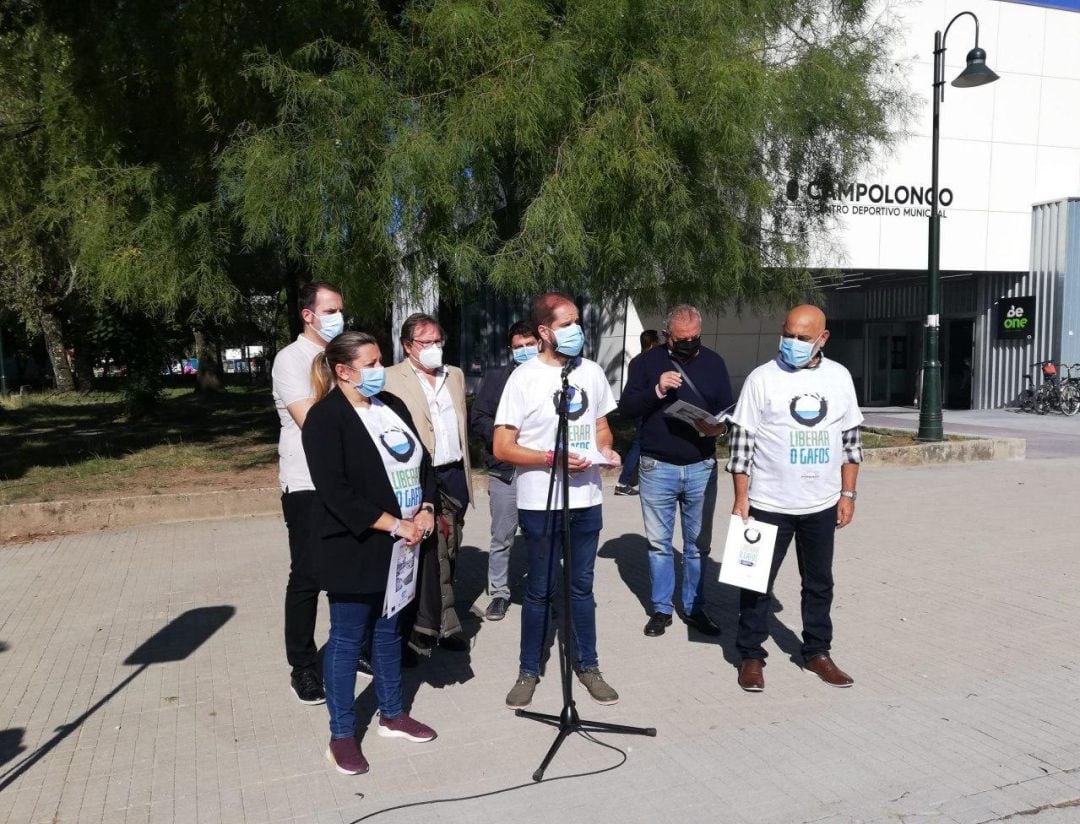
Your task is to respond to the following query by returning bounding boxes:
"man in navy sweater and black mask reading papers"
[619,305,732,636]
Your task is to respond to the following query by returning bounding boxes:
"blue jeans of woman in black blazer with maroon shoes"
[323,592,404,739]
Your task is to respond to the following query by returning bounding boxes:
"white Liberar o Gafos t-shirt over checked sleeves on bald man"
[732,356,863,515]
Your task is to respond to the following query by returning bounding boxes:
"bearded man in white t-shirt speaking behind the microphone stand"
[494,292,620,710]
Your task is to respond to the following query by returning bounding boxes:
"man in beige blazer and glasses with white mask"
[386,312,473,656]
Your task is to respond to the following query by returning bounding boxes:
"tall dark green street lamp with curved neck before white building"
[918,12,998,441]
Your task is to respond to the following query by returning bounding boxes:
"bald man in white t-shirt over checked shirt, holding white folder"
[727,306,863,692]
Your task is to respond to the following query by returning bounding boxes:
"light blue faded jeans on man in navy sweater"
[638,455,716,616]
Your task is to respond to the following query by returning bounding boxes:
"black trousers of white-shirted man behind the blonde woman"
[281,491,319,675]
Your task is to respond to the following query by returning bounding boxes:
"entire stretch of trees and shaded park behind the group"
[0,0,908,490]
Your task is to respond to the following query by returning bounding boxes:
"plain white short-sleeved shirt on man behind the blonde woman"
[270,335,323,492]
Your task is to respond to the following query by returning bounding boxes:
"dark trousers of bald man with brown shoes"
[735,505,836,659]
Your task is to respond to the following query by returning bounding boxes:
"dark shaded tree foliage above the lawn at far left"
[0,0,367,389]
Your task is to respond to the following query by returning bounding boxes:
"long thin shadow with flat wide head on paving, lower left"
[0,606,237,793]
